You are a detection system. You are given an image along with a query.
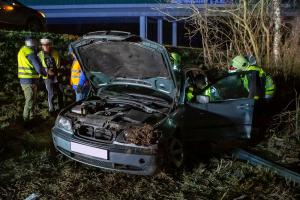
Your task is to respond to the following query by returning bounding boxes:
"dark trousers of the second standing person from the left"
[44,79,63,112]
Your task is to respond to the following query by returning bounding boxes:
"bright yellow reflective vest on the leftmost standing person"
[18,46,39,79]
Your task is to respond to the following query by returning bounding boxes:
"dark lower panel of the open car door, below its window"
[185,99,254,141]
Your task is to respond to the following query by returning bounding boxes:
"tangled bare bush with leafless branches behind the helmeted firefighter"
[170,0,299,73]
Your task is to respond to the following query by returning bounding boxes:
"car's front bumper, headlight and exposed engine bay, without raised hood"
[52,96,170,175]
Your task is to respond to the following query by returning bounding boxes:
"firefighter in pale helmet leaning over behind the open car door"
[228,55,276,100]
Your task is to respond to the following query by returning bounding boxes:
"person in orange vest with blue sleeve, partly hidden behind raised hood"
[69,48,90,101]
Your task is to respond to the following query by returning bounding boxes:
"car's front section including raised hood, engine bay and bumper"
[52,32,176,175]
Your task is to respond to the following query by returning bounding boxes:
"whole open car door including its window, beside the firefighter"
[184,71,261,142]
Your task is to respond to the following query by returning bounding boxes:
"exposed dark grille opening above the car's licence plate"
[77,125,113,141]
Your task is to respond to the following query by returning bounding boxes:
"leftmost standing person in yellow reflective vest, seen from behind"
[18,38,47,123]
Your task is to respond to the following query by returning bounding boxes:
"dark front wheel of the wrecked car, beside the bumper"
[168,137,184,168]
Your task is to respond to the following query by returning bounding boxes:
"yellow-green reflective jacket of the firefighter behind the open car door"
[243,65,276,99]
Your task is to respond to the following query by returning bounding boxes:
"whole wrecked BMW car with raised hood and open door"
[52,31,264,175]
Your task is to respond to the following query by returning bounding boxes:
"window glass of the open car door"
[201,74,249,102]
